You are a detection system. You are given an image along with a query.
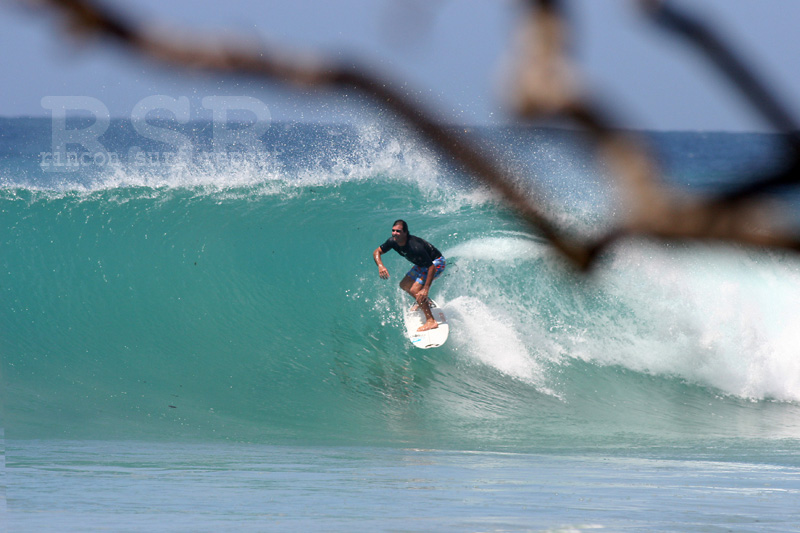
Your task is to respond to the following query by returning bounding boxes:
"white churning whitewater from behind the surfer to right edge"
[442,233,800,402]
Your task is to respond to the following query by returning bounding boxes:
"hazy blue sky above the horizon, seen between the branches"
[0,0,800,131]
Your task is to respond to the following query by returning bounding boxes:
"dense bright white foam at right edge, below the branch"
[587,243,800,401]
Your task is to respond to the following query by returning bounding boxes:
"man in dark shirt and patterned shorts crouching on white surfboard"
[372,220,445,331]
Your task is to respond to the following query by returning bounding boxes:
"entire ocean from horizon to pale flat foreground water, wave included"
[0,117,800,532]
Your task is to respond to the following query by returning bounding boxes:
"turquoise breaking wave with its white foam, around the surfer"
[0,119,800,451]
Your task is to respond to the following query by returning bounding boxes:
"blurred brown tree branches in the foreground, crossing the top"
[18,0,800,269]
